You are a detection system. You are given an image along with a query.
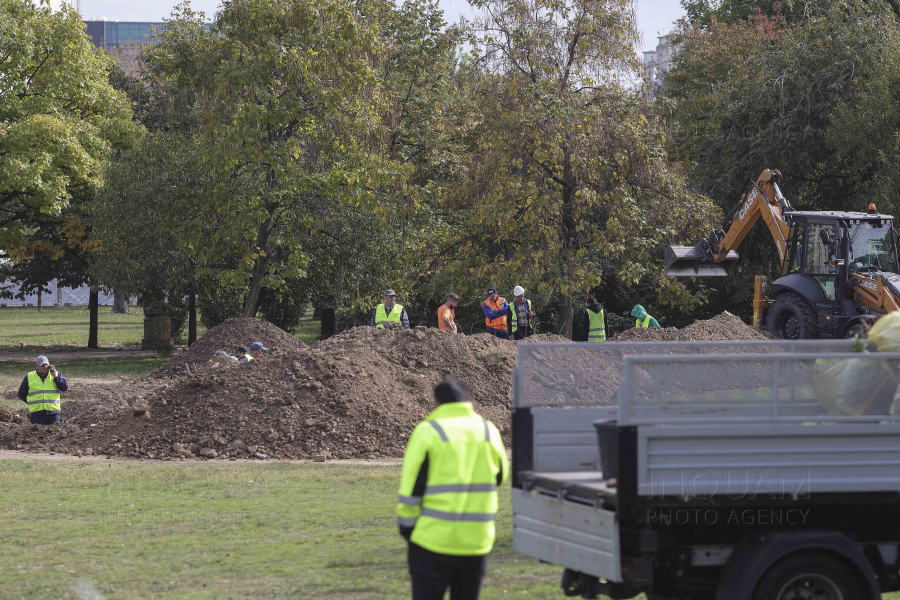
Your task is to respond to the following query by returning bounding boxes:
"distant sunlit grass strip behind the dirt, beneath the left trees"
[0,306,319,346]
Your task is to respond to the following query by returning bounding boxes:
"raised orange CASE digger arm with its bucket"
[665,169,791,277]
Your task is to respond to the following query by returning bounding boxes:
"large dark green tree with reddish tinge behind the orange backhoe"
[663,2,898,314]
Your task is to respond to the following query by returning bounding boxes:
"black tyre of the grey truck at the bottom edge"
[753,552,863,600]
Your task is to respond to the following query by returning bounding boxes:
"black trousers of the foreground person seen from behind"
[409,542,487,600]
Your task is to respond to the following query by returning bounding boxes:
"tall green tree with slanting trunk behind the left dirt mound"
[147,0,392,317]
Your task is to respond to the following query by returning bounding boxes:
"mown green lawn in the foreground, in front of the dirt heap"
[0,460,562,600]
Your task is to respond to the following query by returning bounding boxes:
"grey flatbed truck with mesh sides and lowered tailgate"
[512,340,900,600]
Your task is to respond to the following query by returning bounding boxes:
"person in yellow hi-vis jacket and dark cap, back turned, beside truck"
[397,380,509,600]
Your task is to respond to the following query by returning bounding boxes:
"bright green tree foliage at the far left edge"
[0,0,136,252]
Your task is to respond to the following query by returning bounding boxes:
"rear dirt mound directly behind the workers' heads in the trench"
[152,319,306,377]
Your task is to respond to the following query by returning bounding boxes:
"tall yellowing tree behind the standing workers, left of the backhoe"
[448,0,712,337]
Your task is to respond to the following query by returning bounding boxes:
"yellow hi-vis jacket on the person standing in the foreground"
[397,402,509,556]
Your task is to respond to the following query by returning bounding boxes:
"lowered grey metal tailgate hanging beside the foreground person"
[512,488,622,582]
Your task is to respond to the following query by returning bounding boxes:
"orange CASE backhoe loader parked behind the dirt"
[665,169,900,339]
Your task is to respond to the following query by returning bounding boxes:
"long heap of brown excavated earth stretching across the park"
[0,313,768,460]
